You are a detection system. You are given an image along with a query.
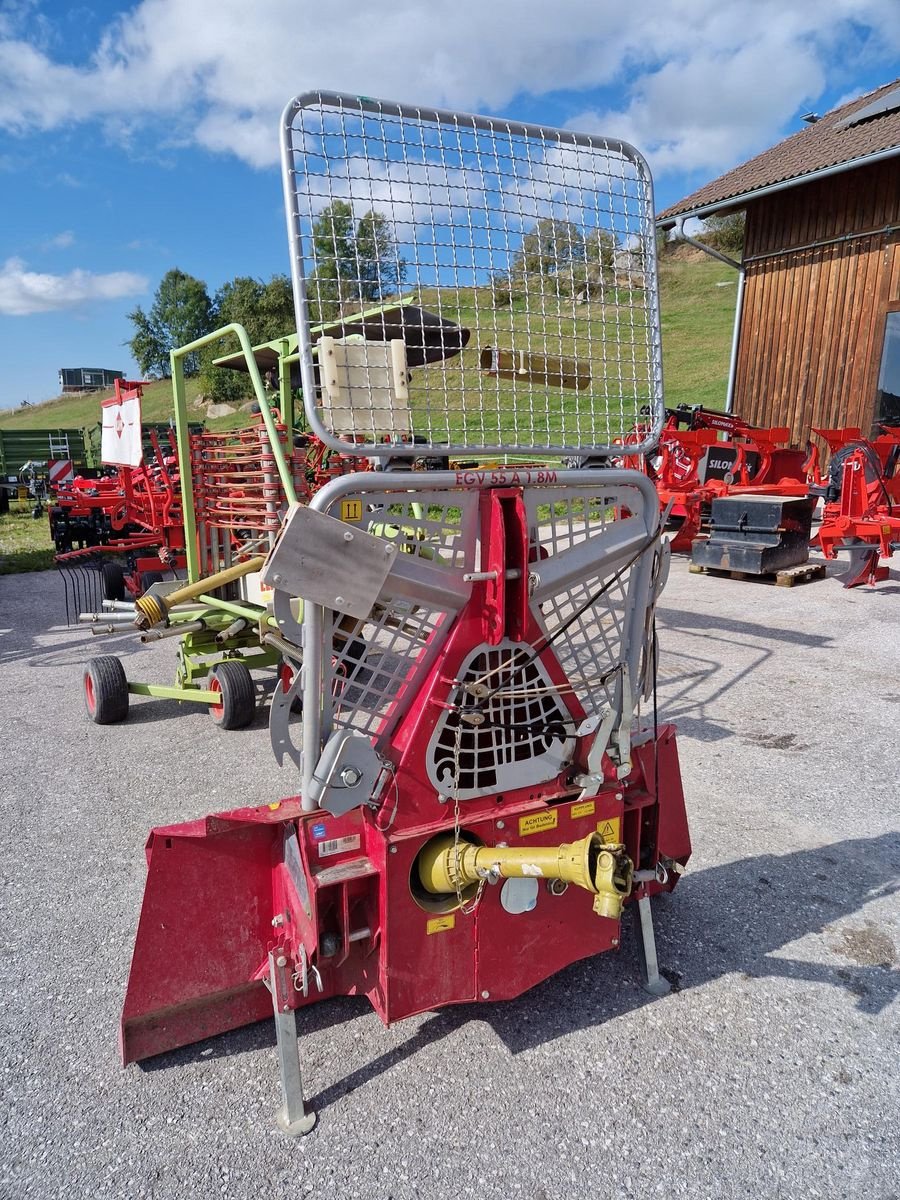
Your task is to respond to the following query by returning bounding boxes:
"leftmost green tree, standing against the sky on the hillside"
[127,266,215,376]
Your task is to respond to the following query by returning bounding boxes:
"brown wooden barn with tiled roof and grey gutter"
[658,80,900,443]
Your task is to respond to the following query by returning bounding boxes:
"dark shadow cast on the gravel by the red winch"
[140,834,900,1111]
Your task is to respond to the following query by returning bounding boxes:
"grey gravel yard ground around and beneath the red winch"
[0,562,900,1200]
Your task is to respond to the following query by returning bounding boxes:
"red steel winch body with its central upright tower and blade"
[121,477,691,1062]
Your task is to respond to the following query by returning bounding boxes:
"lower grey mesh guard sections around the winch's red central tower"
[322,477,656,799]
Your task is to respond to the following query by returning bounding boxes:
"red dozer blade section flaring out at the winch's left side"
[119,800,300,1064]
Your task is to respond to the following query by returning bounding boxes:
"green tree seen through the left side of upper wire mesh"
[307,200,407,324]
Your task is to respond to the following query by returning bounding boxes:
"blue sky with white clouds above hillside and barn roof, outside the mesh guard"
[0,0,900,407]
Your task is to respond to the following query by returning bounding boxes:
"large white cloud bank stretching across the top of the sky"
[0,0,900,182]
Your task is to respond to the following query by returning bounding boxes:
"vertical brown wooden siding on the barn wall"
[734,157,900,443]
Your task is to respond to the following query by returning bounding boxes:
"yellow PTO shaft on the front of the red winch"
[419,833,634,920]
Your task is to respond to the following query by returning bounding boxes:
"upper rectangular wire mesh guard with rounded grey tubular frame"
[283,94,662,455]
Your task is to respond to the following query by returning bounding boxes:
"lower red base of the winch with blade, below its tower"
[120,726,691,1063]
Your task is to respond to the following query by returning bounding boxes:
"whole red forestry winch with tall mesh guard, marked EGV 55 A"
[111,92,690,1134]
